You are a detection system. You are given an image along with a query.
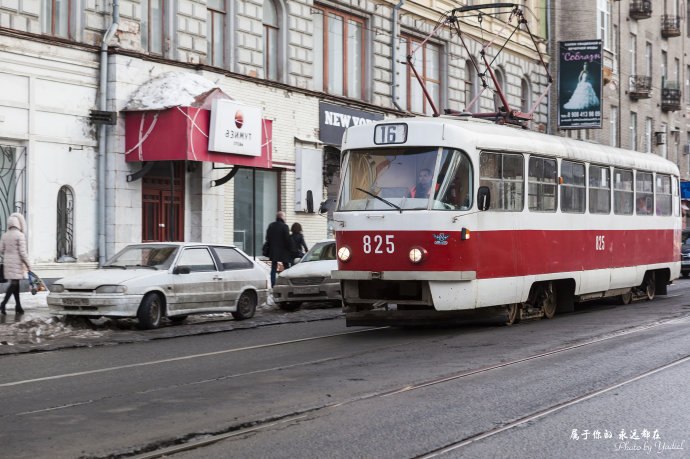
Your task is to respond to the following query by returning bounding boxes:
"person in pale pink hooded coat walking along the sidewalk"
[0,213,31,314]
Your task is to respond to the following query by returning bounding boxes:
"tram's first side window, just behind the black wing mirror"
[479,152,525,212]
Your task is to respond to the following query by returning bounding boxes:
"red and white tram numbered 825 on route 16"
[333,117,682,325]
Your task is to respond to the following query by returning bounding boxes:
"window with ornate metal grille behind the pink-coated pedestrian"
[0,144,26,233]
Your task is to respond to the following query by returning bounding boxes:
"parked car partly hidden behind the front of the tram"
[273,239,342,311]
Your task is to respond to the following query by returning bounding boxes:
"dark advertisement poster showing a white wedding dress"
[558,40,602,129]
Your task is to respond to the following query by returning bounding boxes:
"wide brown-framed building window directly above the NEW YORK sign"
[312,6,364,99]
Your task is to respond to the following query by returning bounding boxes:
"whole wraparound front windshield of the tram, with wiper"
[338,147,473,211]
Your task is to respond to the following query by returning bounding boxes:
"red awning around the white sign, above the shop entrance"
[125,107,273,169]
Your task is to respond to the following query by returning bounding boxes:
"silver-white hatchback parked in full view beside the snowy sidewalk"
[48,242,270,329]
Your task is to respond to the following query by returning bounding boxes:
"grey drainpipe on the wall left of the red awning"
[98,0,120,266]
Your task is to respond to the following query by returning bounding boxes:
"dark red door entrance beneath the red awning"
[141,161,185,242]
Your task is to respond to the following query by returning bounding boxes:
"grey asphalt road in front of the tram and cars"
[0,280,690,458]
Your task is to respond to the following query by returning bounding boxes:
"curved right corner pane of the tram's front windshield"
[432,148,472,210]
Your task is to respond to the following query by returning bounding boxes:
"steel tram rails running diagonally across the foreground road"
[118,314,690,459]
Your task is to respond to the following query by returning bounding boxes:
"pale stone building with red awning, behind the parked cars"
[0,0,548,278]
